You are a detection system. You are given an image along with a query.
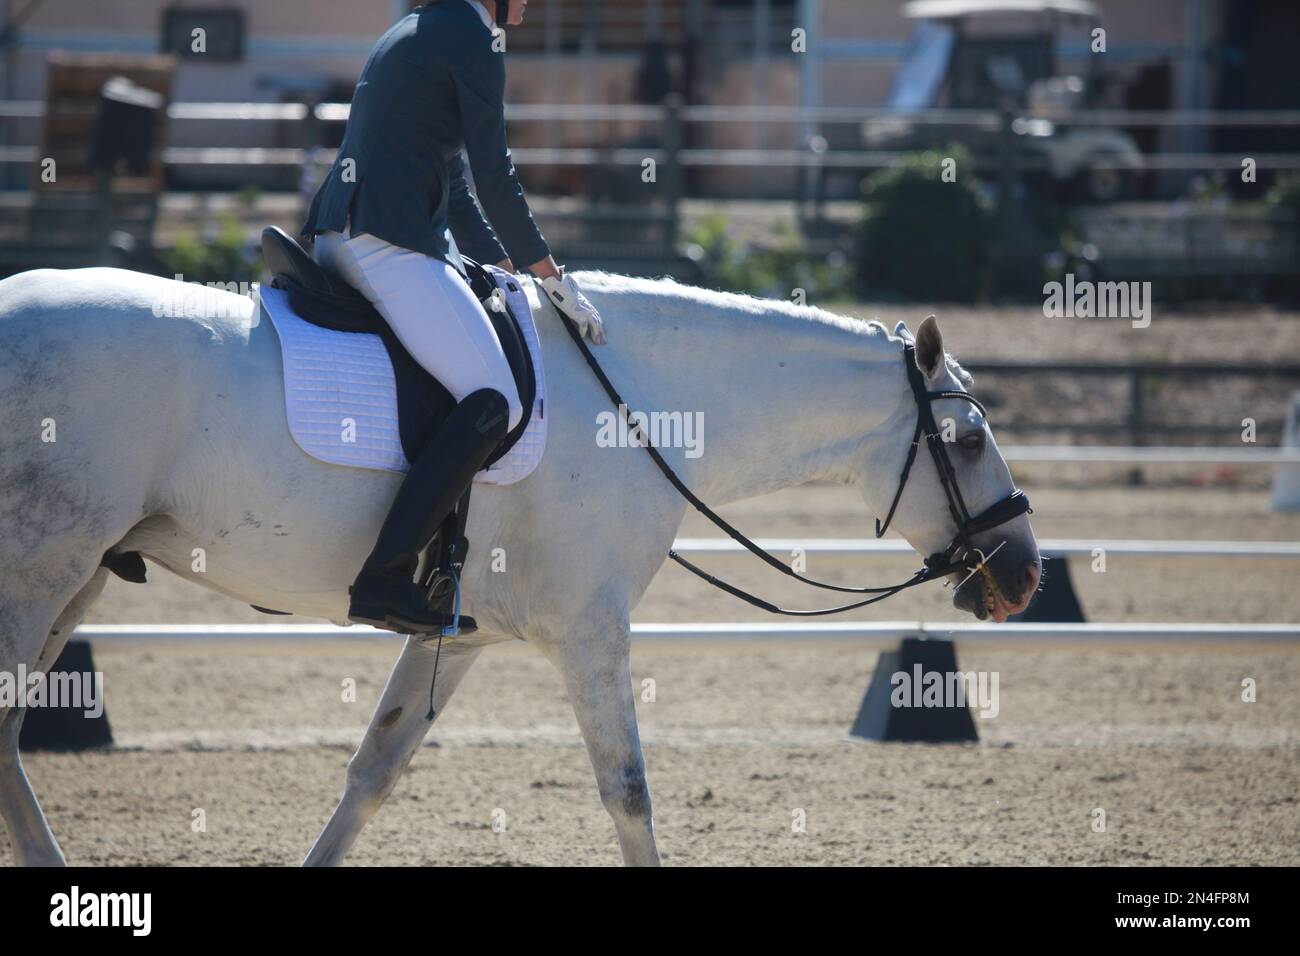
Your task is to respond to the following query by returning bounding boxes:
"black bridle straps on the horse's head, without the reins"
[876,342,1031,578]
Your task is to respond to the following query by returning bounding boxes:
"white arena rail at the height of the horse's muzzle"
[673,537,1300,558]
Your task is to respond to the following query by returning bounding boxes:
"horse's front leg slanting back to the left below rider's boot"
[303,639,484,866]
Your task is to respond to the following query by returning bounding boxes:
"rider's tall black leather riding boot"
[347,389,510,633]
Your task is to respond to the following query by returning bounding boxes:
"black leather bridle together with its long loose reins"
[560,310,1030,618]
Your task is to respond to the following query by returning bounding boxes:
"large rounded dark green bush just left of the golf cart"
[859,146,993,302]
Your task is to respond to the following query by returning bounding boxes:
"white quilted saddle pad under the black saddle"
[259,265,546,485]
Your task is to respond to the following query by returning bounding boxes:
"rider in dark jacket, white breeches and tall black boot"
[303,0,605,633]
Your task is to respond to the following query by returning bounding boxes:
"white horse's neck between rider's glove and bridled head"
[569,278,897,505]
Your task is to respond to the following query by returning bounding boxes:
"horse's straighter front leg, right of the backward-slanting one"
[550,619,659,866]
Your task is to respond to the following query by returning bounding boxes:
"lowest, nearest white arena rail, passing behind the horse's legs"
[75,620,1300,646]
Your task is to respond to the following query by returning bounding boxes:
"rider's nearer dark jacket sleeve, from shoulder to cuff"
[454,46,551,270]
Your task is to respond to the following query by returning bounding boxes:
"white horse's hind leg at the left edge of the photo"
[0,568,108,866]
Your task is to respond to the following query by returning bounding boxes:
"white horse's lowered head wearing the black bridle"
[861,316,1043,622]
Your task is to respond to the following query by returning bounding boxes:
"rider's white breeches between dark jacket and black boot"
[316,233,524,428]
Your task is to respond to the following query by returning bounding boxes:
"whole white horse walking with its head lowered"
[0,269,1040,864]
